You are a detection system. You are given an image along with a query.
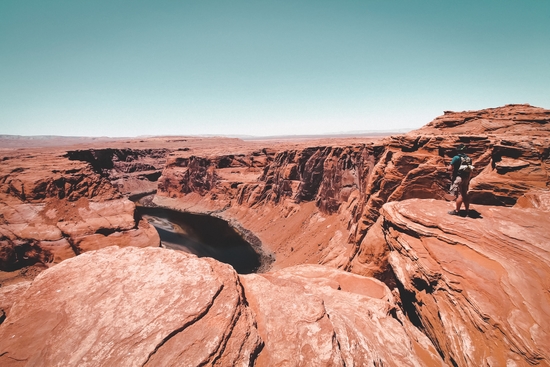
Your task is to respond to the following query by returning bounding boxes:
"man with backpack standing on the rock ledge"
[448,144,474,215]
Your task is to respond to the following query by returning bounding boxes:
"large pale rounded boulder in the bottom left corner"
[0,247,261,366]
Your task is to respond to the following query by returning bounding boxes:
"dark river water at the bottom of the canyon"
[137,207,261,274]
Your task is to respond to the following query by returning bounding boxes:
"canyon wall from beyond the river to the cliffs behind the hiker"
[154,105,550,268]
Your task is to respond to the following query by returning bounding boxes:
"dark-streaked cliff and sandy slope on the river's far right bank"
[154,145,380,267]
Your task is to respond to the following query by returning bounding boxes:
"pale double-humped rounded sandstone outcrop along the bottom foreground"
[0,247,445,366]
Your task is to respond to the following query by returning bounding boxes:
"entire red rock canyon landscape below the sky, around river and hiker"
[0,105,550,366]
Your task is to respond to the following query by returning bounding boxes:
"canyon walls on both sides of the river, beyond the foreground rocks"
[0,105,550,269]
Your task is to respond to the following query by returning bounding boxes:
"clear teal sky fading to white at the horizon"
[0,0,550,136]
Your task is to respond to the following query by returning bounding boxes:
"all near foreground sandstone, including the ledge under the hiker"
[0,199,550,366]
